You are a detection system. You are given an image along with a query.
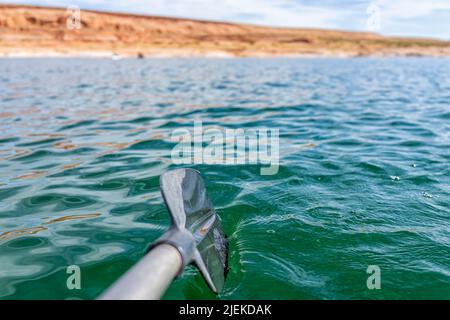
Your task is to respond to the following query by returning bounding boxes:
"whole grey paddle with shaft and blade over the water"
[100,169,228,300]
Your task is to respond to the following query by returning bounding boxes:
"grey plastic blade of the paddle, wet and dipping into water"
[160,169,228,293]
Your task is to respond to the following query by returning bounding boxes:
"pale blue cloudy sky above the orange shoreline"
[0,0,450,39]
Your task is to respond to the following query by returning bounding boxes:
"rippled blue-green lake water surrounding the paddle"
[0,58,450,299]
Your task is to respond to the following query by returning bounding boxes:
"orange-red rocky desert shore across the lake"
[0,5,450,59]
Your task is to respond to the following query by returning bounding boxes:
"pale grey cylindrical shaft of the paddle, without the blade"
[99,244,182,300]
